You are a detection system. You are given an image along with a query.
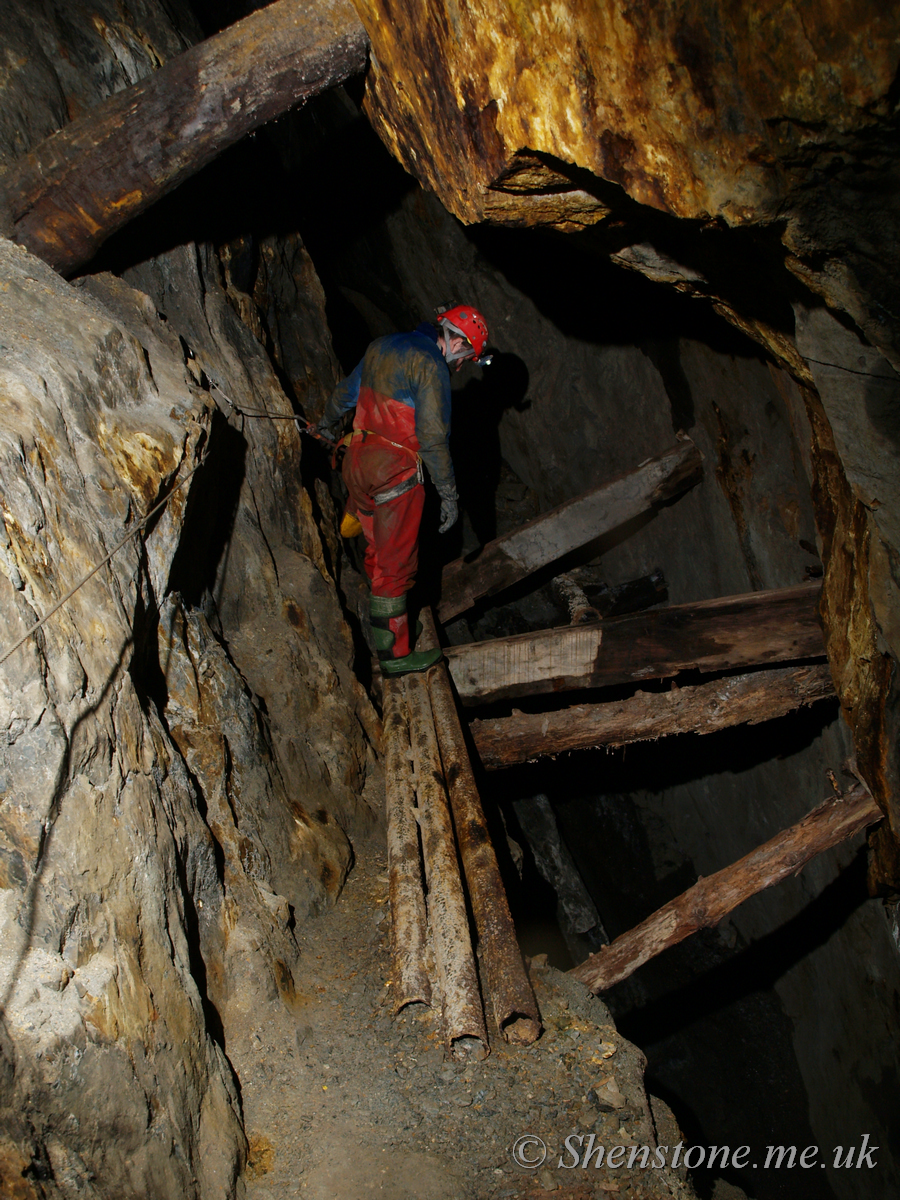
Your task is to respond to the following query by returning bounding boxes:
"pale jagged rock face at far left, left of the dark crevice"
[0,244,241,1195]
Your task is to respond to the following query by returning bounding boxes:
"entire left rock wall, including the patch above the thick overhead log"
[0,5,378,1200]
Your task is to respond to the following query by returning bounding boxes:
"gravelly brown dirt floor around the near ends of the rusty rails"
[241,851,710,1200]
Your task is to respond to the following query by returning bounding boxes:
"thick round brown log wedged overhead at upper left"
[0,0,368,275]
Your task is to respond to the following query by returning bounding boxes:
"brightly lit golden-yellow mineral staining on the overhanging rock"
[359,0,896,224]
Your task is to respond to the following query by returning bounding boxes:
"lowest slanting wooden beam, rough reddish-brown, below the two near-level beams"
[571,784,883,992]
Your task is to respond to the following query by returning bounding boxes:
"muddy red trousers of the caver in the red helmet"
[342,439,425,596]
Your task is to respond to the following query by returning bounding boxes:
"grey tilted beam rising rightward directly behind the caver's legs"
[437,437,703,623]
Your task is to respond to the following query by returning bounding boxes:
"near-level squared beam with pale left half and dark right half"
[445,583,826,704]
